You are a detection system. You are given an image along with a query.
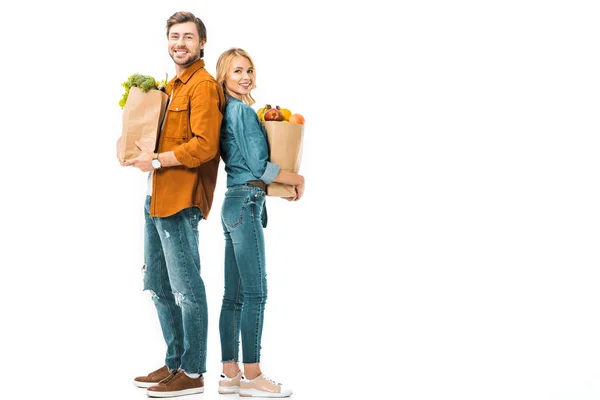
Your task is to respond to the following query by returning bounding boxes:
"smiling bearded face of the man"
[169,22,204,67]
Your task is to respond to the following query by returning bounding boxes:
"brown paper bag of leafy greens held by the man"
[119,87,169,160]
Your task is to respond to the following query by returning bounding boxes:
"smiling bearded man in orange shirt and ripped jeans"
[121,12,225,397]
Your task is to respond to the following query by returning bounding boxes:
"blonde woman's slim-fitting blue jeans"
[219,185,267,364]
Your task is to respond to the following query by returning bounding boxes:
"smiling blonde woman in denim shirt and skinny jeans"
[216,48,304,397]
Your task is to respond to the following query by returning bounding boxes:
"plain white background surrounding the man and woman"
[0,0,600,400]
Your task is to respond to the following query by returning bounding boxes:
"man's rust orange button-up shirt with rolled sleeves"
[150,60,225,218]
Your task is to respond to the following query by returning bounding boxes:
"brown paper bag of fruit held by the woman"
[263,121,304,197]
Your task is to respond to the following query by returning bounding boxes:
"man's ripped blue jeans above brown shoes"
[144,196,208,374]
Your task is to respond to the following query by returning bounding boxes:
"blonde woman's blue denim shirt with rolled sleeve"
[220,96,280,187]
